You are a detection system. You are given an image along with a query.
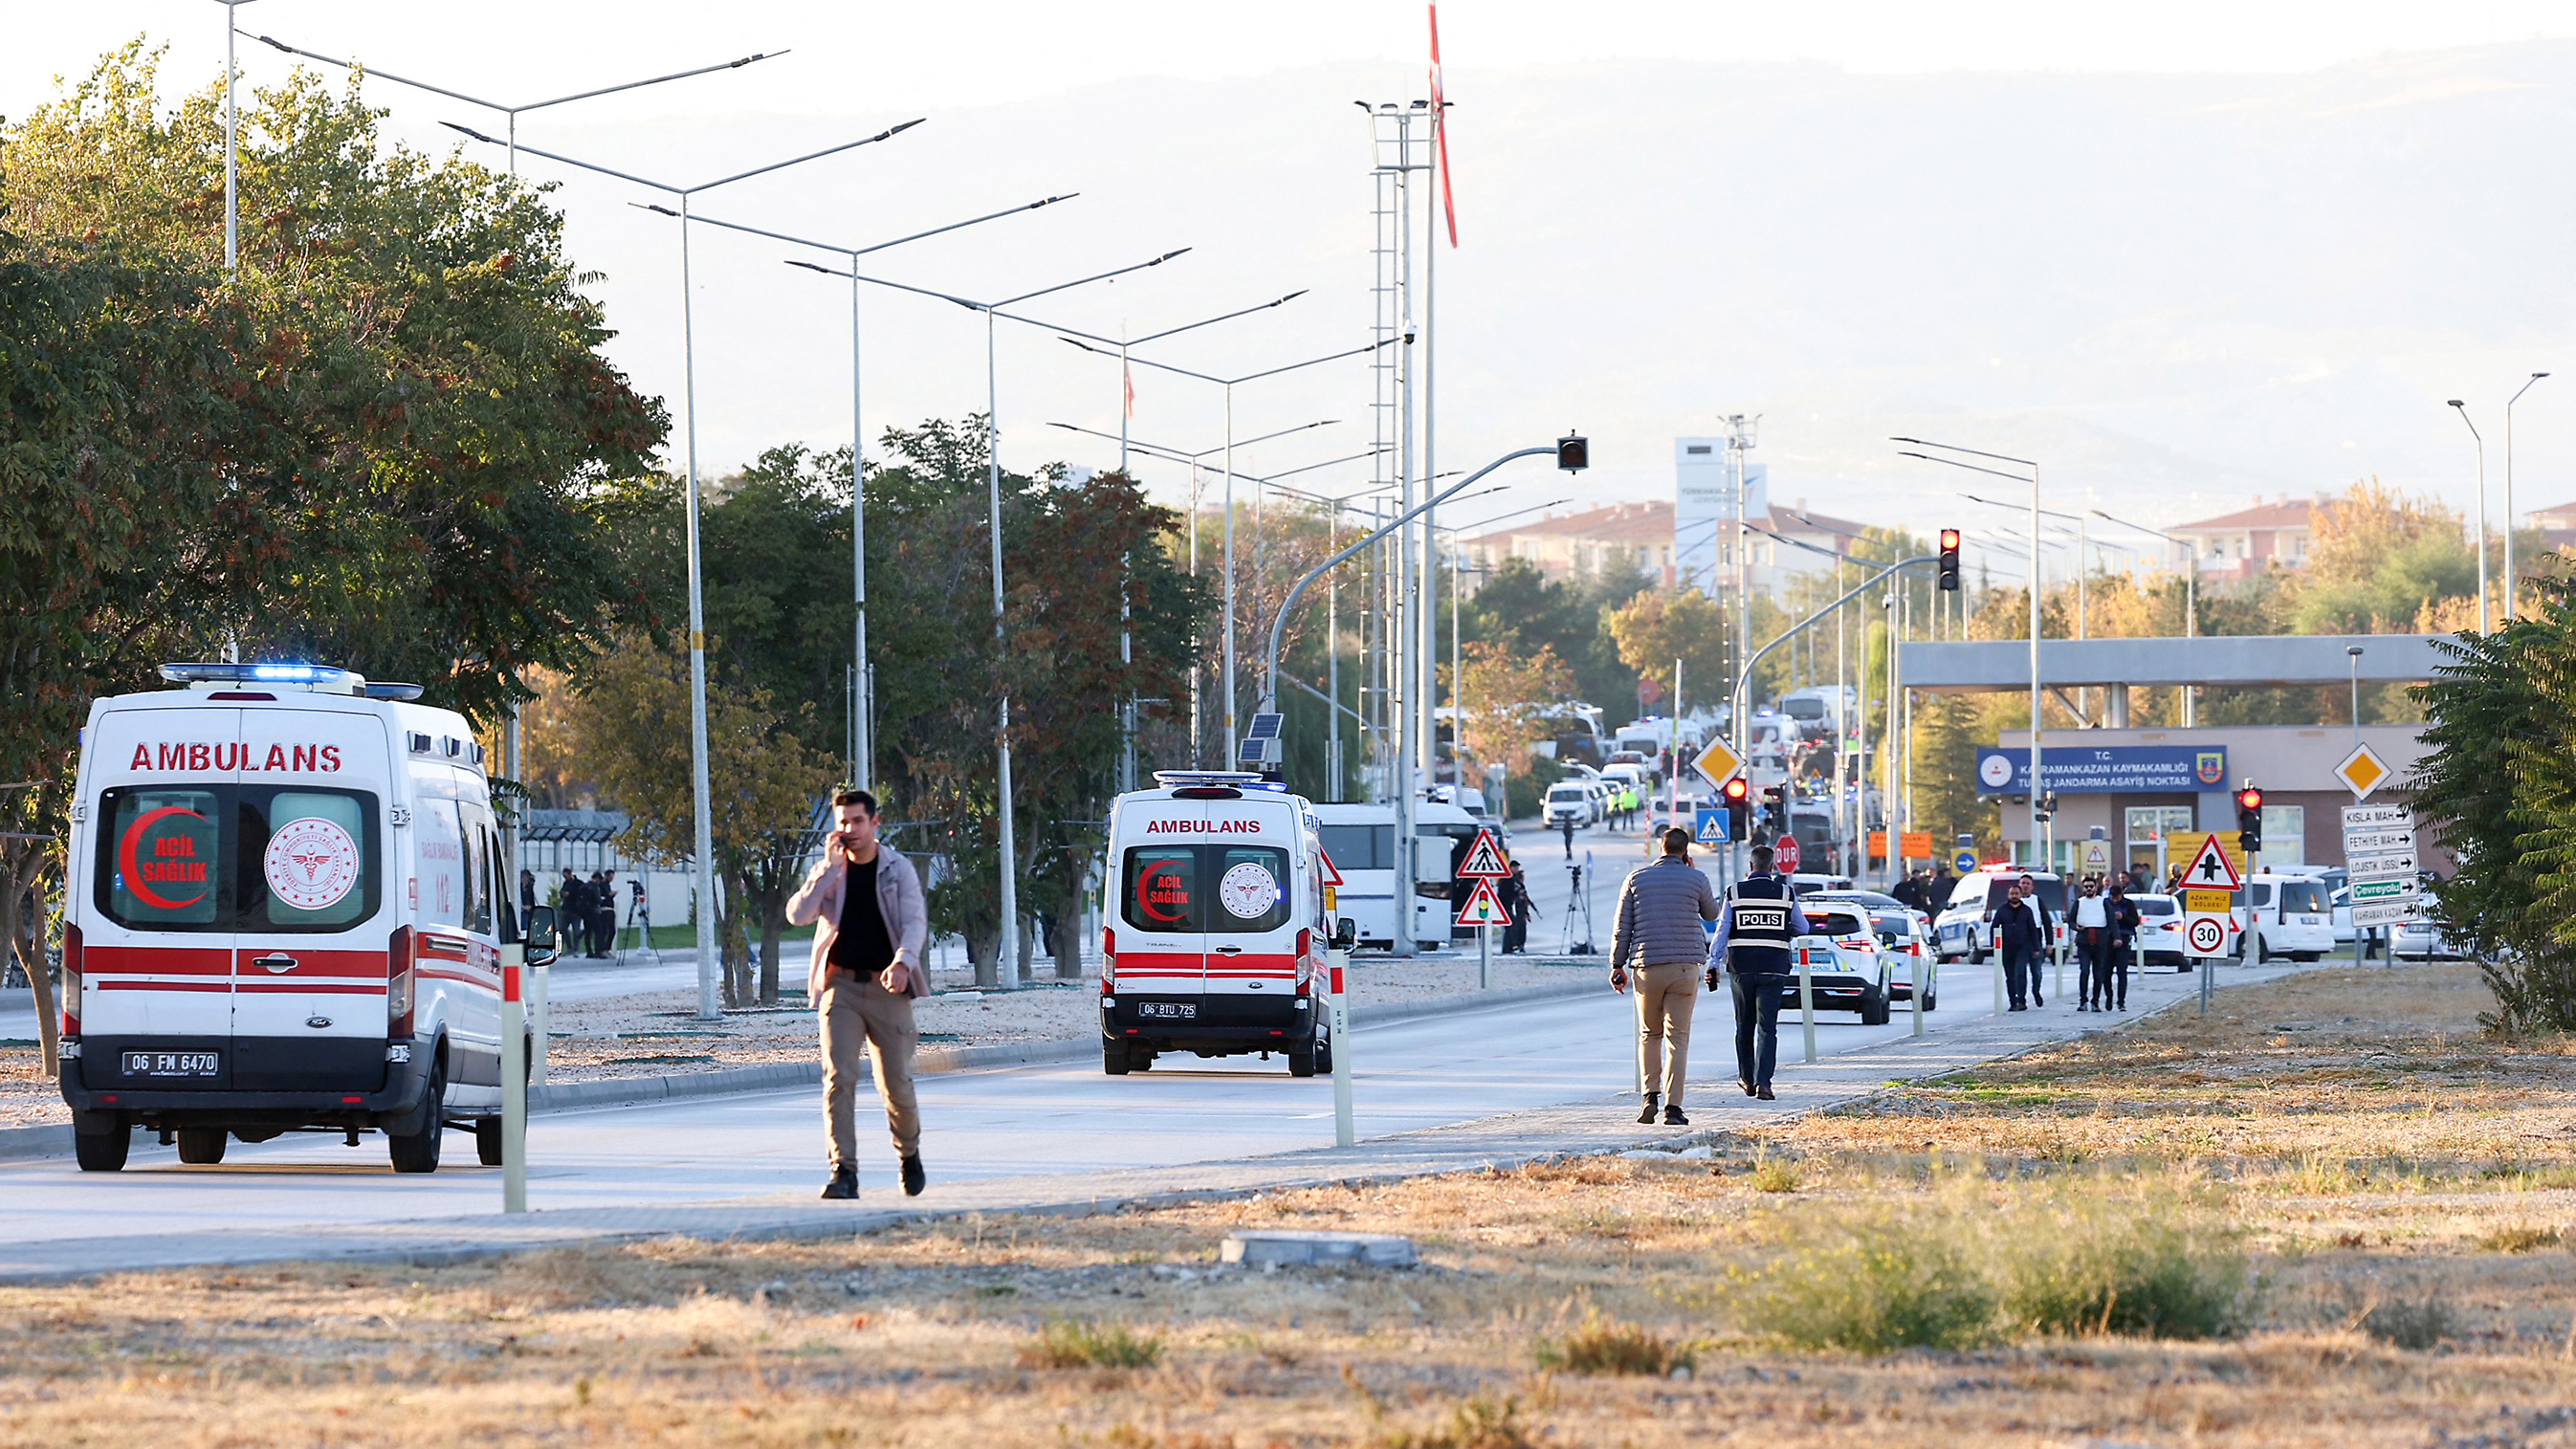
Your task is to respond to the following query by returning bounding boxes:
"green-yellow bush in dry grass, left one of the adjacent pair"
[1741,1220,1996,1353]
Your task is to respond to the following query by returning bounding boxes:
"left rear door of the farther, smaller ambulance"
[1112,798,1208,1027]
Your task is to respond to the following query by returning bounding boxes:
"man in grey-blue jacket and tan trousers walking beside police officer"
[1610,826,1718,1128]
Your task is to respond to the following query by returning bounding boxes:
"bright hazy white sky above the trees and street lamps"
[14,0,2576,560]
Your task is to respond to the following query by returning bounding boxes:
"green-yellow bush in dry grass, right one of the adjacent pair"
[1996,1197,2249,1338]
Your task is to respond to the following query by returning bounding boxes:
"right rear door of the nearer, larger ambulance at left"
[231,705,394,1094]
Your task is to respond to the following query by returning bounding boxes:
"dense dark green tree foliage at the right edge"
[2409,579,2576,1032]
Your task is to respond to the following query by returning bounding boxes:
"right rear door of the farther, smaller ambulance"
[1198,796,1304,1037]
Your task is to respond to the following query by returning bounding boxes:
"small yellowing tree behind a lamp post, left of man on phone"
[564,633,835,1006]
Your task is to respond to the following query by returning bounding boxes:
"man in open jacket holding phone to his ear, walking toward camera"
[788,790,930,1197]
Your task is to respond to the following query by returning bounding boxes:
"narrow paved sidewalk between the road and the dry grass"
[0,965,2313,1282]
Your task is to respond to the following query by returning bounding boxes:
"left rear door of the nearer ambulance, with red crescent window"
[79,695,239,1091]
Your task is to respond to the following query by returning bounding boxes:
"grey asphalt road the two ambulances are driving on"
[0,936,2171,1240]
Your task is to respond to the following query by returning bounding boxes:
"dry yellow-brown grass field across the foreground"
[0,968,2576,1449]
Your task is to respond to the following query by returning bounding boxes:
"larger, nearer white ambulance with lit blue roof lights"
[62,664,554,1174]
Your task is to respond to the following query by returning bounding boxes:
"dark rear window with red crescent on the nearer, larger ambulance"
[96,785,384,932]
